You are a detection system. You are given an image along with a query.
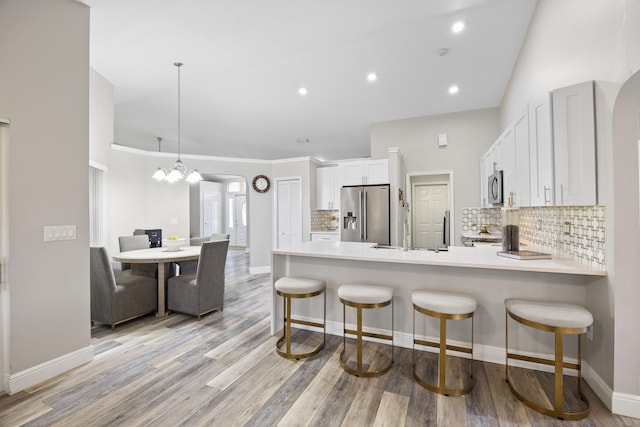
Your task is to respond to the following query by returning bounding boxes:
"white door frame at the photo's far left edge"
[0,117,11,392]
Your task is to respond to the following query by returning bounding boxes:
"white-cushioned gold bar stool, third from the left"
[411,290,477,396]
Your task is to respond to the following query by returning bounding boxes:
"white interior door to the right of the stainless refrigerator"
[411,184,449,249]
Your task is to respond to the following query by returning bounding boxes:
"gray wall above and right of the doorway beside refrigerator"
[371,108,499,245]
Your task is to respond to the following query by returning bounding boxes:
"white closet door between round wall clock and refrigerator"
[276,178,302,249]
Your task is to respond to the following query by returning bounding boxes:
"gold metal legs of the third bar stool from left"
[413,304,475,396]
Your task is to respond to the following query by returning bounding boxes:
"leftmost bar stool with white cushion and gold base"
[274,277,327,359]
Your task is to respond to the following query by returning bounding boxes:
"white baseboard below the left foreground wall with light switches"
[4,345,93,394]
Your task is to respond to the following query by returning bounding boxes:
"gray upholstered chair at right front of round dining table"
[167,240,229,320]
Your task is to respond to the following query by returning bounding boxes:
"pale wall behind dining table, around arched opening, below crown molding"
[109,148,273,269]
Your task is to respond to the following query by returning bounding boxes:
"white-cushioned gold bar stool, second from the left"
[338,283,393,377]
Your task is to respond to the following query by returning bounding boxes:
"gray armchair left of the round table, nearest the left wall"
[90,247,158,329]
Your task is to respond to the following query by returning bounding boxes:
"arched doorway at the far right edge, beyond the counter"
[610,71,640,406]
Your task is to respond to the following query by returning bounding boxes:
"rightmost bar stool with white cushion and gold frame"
[504,298,593,420]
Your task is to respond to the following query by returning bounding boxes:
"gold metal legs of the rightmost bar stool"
[505,310,589,420]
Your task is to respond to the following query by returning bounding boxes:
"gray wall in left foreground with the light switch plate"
[0,0,93,382]
